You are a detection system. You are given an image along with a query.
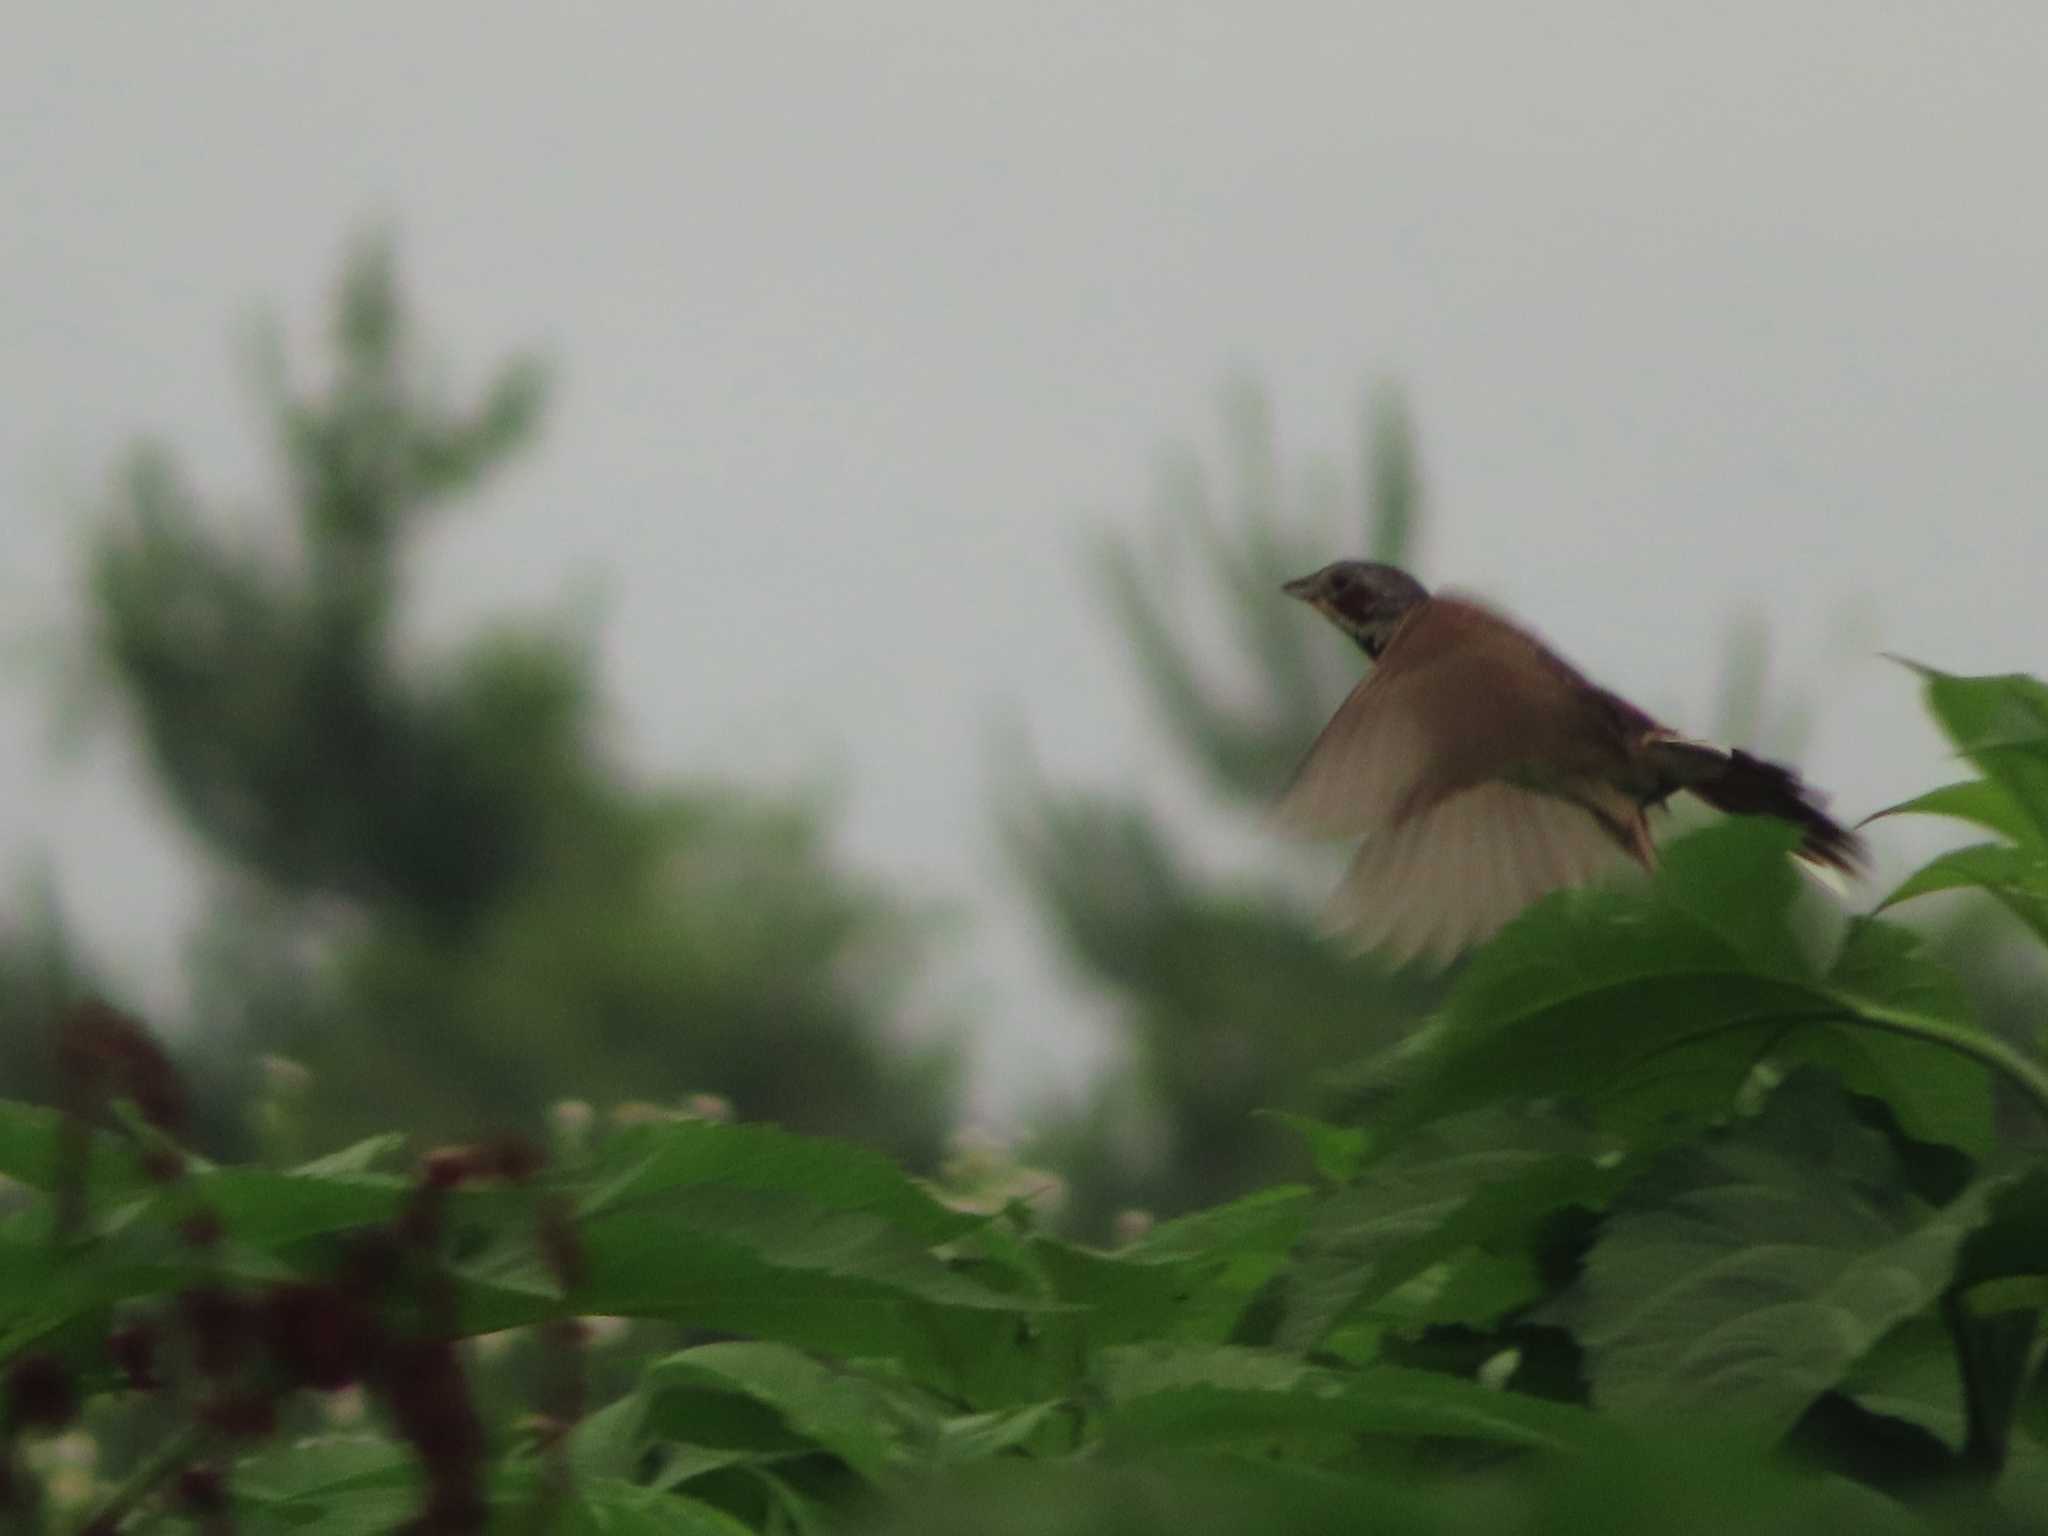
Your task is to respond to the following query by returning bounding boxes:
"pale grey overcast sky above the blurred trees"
[0,0,2048,1104]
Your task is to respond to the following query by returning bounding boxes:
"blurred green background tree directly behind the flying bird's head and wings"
[1004,379,1442,1235]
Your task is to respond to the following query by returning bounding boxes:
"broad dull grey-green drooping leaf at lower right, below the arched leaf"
[1542,1073,1997,1442]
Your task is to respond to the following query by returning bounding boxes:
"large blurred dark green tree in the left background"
[64,244,958,1165]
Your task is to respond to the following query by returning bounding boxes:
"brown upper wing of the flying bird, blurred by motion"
[1276,598,1612,838]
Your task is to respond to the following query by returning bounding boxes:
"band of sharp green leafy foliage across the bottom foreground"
[12,676,2048,1536]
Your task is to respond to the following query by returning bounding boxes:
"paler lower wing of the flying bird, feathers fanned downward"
[1329,782,1628,965]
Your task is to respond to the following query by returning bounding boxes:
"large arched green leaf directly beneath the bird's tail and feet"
[1389,819,2015,1145]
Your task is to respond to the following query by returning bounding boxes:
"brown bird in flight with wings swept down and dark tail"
[1276,559,1864,967]
